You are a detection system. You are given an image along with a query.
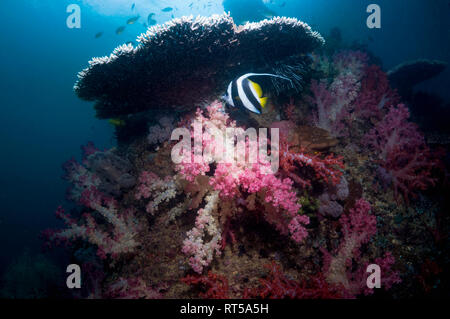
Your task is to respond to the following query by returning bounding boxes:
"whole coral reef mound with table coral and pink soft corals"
[40,15,449,299]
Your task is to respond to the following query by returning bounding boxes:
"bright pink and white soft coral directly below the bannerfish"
[170,103,309,273]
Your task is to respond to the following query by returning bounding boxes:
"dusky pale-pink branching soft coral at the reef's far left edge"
[43,143,140,258]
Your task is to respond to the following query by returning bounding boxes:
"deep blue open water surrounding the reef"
[0,0,450,280]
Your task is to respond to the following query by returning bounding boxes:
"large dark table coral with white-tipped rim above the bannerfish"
[74,14,324,118]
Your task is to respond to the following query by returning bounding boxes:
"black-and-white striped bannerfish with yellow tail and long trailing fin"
[222,73,291,114]
